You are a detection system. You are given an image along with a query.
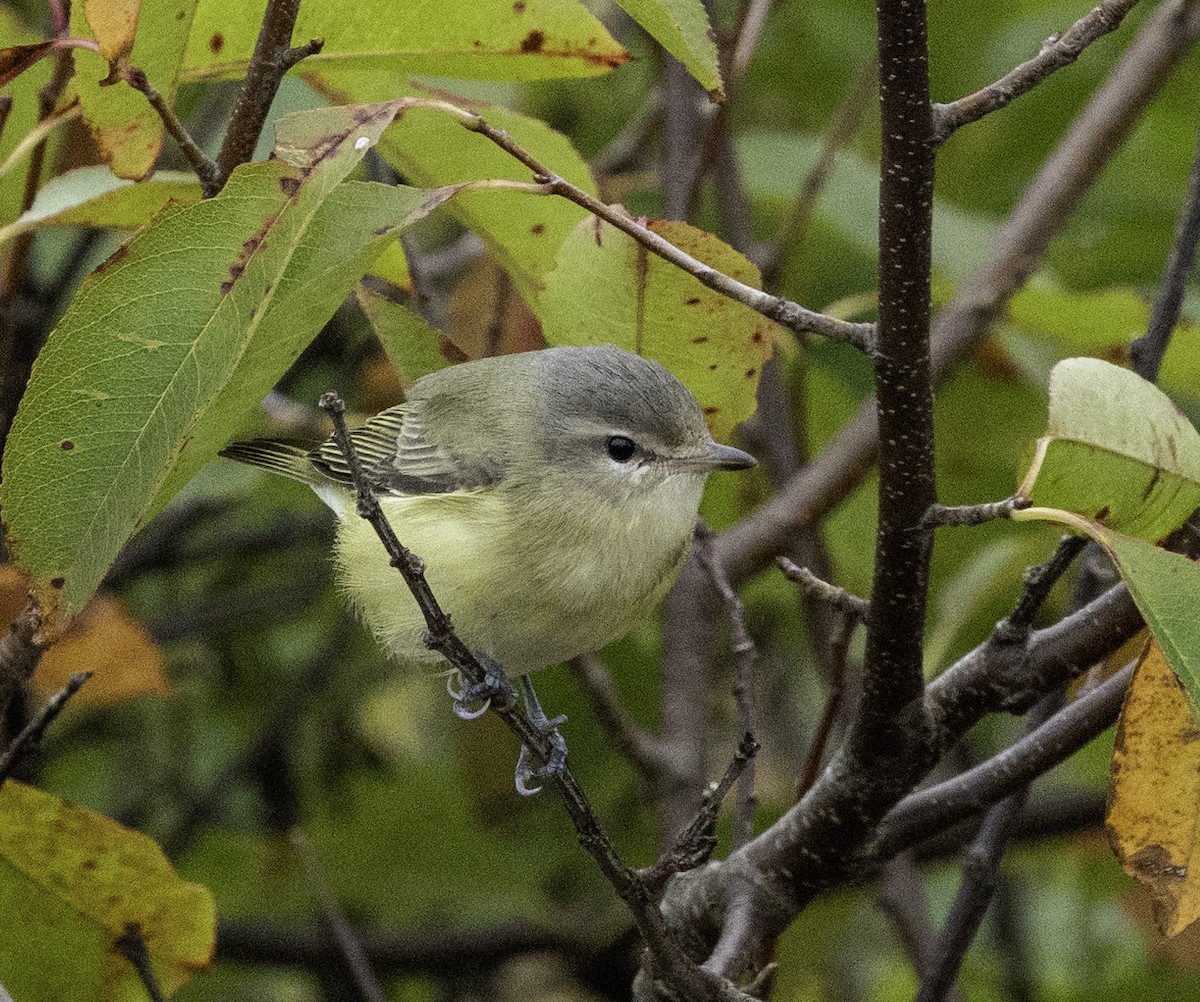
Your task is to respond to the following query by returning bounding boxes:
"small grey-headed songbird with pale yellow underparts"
[222,344,755,792]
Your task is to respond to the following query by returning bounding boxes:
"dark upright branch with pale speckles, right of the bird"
[851,0,936,757]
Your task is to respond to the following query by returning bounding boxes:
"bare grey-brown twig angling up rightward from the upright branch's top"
[934,0,1138,144]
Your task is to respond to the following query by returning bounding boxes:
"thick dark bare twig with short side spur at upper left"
[211,0,323,198]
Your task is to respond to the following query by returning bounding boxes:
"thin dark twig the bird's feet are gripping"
[320,392,748,1000]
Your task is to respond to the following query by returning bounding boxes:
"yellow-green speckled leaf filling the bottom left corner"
[0,780,216,1002]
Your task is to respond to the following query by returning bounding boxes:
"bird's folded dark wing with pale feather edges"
[310,403,500,496]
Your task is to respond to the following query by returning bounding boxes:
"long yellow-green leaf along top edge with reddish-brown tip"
[185,0,629,82]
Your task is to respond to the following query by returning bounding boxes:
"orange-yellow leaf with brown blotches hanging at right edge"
[1105,642,1200,936]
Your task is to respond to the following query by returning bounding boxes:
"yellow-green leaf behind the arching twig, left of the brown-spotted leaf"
[306,73,596,305]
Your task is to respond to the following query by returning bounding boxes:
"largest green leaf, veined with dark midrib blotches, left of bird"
[0,102,455,636]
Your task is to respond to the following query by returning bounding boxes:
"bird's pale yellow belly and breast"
[336,484,698,674]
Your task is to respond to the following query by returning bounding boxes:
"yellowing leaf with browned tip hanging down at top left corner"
[68,0,196,180]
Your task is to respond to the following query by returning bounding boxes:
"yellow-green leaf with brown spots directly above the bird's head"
[535,217,774,439]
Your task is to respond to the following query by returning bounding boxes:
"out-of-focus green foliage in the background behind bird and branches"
[7,0,1200,1002]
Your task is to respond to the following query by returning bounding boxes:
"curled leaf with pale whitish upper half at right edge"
[1019,359,1200,541]
